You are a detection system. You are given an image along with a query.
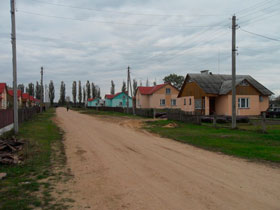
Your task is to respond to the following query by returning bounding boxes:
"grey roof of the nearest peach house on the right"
[178,73,273,97]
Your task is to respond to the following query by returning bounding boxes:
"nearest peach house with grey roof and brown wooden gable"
[178,70,273,116]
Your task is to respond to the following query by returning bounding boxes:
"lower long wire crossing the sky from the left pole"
[18,10,225,28]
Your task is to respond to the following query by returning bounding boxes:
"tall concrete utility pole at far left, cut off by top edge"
[11,0,18,134]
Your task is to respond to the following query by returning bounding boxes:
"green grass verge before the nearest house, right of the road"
[144,120,280,163]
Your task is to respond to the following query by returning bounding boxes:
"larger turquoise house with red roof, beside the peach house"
[105,92,132,108]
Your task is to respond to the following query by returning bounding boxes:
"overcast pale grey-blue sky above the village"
[0,0,280,100]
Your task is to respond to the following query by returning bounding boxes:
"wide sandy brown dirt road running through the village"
[57,108,280,210]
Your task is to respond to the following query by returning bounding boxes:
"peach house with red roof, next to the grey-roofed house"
[136,83,180,109]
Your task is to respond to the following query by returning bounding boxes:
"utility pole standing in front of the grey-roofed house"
[232,15,237,129]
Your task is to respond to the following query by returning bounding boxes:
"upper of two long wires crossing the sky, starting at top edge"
[27,0,225,17]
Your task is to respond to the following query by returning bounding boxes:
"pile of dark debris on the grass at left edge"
[0,137,24,164]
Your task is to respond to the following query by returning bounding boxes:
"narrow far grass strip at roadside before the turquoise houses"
[71,108,143,119]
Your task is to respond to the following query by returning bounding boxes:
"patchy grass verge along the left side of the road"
[0,109,69,210]
